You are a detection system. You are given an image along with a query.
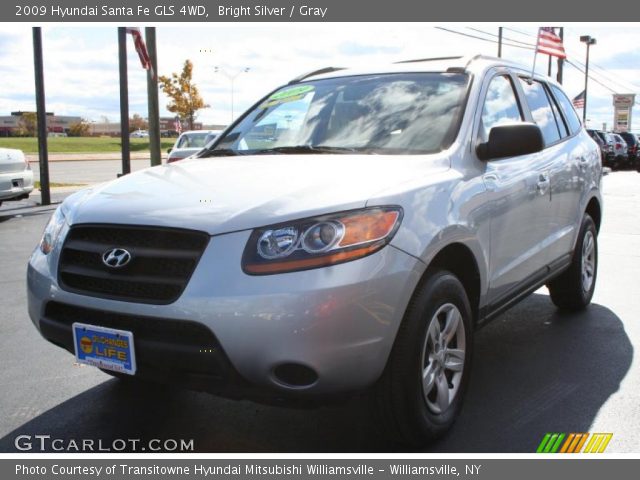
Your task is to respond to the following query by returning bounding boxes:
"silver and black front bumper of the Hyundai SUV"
[28,231,423,397]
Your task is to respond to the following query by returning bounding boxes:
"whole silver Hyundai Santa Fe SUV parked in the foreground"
[28,57,602,443]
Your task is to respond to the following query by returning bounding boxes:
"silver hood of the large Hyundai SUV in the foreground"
[63,154,449,235]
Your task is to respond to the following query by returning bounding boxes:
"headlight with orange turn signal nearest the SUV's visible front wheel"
[242,207,402,275]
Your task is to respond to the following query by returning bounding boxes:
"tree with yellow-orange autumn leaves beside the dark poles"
[159,60,209,130]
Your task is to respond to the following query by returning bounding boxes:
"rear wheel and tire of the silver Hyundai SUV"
[547,214,598,312]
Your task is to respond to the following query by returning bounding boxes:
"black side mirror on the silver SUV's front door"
[476,122,544,160]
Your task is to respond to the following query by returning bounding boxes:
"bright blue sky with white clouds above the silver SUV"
[0,23,640,132]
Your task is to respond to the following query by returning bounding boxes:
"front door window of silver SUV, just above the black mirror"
[480,75,522,141]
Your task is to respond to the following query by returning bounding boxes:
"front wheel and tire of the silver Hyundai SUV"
[372,270,473,447]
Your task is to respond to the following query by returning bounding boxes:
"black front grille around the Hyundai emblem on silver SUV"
[58,225,209,304]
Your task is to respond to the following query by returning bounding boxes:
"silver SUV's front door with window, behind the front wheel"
[476,70,550,305]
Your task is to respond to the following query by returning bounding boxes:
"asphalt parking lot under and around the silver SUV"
[0,167,640,453]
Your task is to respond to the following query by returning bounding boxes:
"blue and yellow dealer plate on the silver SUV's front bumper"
[72,323,136,375]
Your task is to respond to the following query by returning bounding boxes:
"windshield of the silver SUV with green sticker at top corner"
[208,73,469,155]
